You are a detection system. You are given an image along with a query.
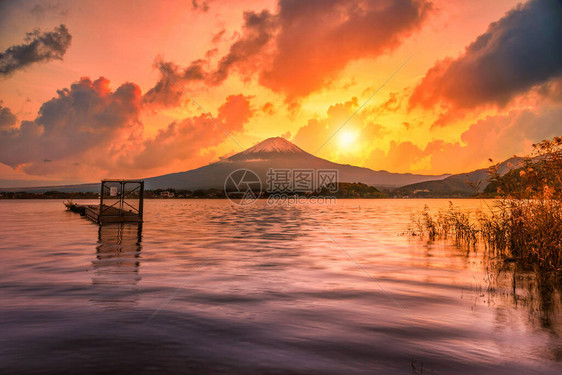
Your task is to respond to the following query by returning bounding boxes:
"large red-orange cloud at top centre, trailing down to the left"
[146,0,431,106]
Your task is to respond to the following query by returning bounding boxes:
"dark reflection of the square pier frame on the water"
[92,223,142,308]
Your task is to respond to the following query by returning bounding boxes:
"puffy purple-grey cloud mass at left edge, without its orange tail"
[0,77,141,172]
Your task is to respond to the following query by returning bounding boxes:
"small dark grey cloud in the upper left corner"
[0,25,72,76]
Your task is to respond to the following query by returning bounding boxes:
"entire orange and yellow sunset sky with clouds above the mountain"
[0,0,562,187]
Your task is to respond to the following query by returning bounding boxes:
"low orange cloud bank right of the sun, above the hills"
[365,105,562,173]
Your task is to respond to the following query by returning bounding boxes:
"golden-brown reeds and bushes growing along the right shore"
[410,137,562,282]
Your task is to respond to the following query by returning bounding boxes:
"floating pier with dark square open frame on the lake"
[66,180,144,225]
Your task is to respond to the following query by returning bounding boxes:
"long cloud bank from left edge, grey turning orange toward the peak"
[0,72,256,179]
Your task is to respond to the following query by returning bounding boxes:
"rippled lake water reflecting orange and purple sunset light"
[0,200,562,374]
